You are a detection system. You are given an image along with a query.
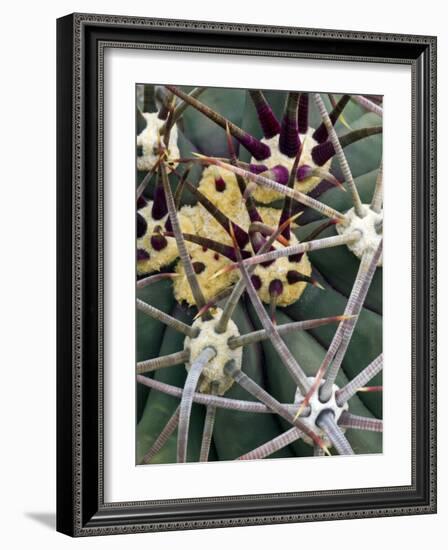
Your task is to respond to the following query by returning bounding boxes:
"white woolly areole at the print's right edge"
[336,204,383,266]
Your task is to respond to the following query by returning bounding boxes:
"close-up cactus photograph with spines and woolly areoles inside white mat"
[136,85,383,464]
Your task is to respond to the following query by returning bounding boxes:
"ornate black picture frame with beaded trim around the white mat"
[57,14,436,536]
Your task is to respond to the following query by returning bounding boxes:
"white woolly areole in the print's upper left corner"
[137,113,180,170]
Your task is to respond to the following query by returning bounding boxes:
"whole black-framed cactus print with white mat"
[57,14,436,536]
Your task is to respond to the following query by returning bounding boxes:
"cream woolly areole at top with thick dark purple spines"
[250,127,331,204]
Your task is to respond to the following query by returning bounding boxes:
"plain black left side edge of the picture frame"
[56,15,75,536]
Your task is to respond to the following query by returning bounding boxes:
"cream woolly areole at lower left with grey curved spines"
[184,308,243,395]
